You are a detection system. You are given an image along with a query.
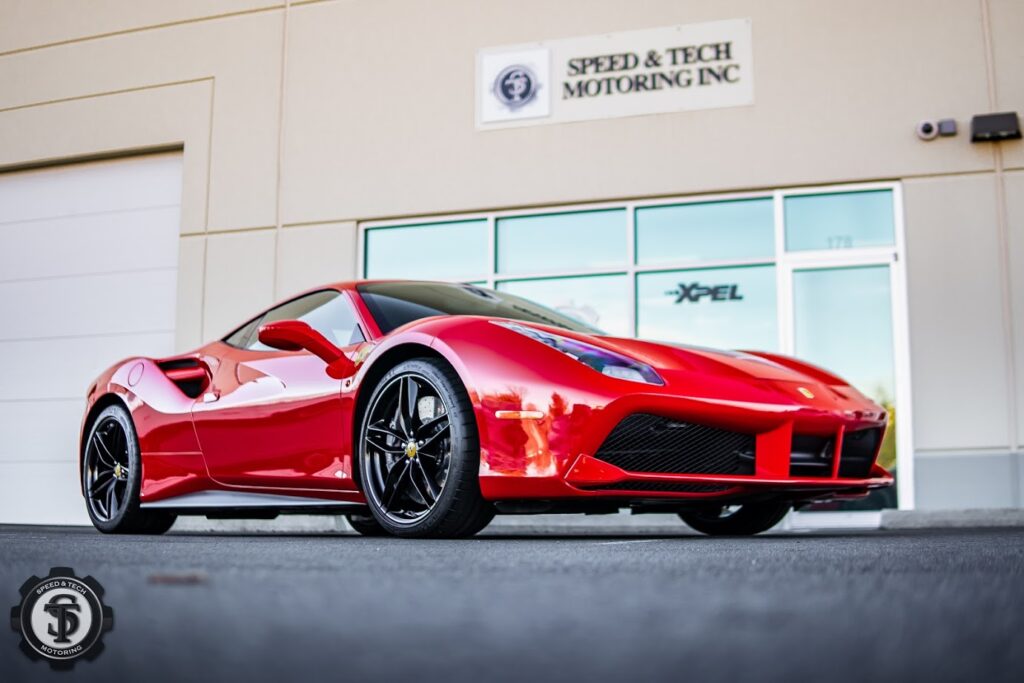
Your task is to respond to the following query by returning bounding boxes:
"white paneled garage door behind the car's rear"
[0,154,181,523]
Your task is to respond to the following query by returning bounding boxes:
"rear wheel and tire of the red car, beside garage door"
[82,405,176,535]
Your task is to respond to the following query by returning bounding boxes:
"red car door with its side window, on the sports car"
[193,290,365,489]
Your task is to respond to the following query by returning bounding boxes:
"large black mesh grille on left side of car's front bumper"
[594,413,755,474]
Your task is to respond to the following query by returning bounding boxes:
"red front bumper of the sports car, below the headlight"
[478,387,893,501]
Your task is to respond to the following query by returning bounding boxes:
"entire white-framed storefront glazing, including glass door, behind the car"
[364,183,912,509]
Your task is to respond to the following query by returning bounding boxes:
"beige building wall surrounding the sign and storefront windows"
[0,0,1024,505]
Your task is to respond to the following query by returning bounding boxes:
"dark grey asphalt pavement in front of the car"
[0,526,1024,683]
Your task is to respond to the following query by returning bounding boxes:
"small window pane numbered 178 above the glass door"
[783,189,895,251]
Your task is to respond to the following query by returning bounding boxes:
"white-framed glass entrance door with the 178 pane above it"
[776,187,910,510]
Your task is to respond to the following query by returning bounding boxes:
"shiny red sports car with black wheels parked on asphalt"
[80,281,893,538]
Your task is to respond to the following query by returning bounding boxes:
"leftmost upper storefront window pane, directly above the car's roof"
[365,219,490,280]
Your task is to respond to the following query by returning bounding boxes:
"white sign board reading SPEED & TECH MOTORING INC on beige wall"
[476,19,754,130]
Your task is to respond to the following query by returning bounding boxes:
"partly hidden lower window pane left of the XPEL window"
[498,273,630,337]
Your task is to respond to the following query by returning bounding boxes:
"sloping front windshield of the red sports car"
[356,282,603,334]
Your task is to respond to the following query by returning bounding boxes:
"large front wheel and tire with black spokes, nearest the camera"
[356,358,495,539]
